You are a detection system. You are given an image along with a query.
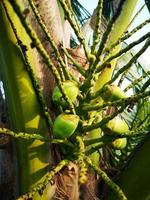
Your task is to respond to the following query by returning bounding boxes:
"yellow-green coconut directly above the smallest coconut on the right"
[104,116,129,134]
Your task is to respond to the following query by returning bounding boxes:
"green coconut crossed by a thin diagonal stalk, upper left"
[52,81,79,106]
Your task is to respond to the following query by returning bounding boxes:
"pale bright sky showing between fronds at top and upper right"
[79,0,150,66]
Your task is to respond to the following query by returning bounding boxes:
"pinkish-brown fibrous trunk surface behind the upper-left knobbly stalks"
[26,0,70,107]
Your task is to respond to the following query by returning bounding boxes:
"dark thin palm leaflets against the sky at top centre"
[71,0,91,25]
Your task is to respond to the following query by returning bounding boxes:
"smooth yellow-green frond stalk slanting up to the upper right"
[83,0,137,166]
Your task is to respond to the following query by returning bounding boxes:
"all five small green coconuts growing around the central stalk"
[52,80,129,149]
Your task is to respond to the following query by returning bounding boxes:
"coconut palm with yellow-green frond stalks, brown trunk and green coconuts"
[0,0,150,200]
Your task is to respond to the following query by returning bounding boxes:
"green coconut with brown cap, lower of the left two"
[53,113,79,139]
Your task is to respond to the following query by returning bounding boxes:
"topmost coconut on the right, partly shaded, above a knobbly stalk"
[101,85,126,101]
